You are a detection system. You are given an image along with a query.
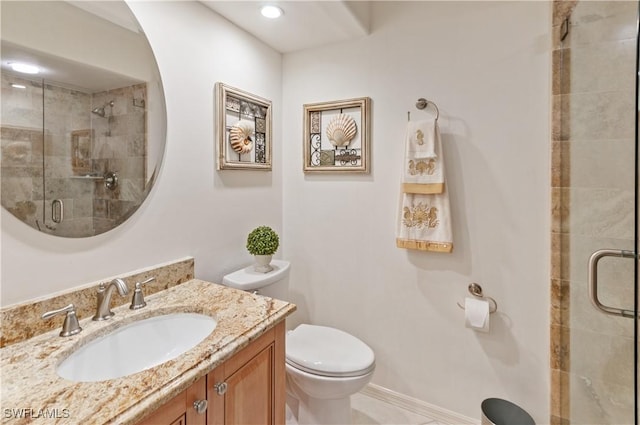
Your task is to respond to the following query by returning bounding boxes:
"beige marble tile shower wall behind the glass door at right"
[551,1,637,424]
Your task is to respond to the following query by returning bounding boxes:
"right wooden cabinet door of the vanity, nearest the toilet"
[207,322,285,425]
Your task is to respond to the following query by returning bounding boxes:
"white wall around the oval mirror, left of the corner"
[1,1,282,306]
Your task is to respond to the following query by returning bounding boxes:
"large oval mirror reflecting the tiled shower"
[0,1,166,237]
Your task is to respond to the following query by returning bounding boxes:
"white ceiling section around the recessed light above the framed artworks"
[200,0,371,53]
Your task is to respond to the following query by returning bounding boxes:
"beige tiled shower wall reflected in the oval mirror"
[0,73,146,236]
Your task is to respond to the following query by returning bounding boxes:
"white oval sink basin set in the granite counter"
[56,313,218,382]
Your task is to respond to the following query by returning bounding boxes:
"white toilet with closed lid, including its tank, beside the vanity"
[222,260,375,425]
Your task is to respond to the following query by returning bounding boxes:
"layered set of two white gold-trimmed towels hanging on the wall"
[396,121,453,252]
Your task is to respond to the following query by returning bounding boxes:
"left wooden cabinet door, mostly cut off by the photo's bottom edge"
[137,376,207,425]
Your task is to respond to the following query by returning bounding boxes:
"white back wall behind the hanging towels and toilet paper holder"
[283,2,551,423]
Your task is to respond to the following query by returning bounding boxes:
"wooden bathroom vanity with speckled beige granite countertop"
[0,279,295,425]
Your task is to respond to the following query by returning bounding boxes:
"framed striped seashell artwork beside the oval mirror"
[215,82,271,171]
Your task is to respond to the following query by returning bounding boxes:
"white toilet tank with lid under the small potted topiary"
[222,260,290,301]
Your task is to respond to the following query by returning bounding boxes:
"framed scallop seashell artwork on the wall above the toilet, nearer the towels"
[303,97,371,173]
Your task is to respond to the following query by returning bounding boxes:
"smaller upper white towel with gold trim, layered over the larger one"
[402,120,444,193]
